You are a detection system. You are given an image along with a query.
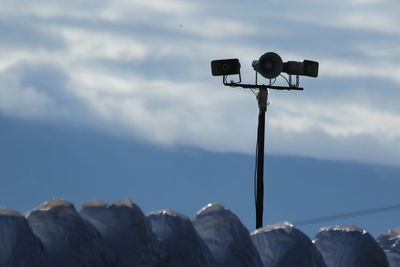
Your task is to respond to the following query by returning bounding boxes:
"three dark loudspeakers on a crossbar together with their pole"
[211,52,319,228]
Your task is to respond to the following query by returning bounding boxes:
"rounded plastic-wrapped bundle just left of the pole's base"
[193,204,262,267]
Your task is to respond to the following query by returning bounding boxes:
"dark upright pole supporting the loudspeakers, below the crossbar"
[256,89,268,229]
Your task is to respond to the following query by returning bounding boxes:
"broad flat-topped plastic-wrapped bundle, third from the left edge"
[80,200,159,267]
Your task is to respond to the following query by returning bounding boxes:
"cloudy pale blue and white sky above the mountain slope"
[0,0,400,166]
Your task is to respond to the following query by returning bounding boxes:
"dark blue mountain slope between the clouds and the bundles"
[0,116,400,237]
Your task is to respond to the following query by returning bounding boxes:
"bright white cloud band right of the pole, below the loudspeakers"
[270,101,400,140]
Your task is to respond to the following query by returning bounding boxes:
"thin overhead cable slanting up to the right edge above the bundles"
[293,204,400,226]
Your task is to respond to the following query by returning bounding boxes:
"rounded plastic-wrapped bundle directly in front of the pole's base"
[251,222,326,267]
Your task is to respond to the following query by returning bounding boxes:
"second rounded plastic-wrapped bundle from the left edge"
[26,199,114,267]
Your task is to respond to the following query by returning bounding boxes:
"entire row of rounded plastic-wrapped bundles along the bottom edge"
[0,199,400,267]
